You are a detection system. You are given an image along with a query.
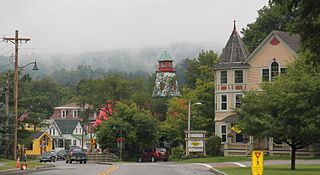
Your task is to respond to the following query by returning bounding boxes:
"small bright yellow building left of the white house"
[26,132,52,156]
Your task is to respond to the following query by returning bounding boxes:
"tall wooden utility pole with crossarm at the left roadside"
[2,30,30,160]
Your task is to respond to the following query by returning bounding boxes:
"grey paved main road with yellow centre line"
[1,161,212,175]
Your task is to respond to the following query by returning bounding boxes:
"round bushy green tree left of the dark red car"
[97,102,158,159]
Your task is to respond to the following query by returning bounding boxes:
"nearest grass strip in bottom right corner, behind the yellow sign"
[217,164,320,175]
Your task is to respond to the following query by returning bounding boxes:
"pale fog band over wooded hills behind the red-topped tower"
[9,44,218,77]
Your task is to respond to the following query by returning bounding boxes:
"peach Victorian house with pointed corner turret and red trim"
[214,21,317,156]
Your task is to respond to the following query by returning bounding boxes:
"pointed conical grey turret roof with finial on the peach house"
[219,21,249,64]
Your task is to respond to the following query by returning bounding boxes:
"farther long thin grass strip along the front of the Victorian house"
[170,156,319,163]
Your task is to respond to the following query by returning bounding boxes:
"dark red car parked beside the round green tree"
[138,148,169,162]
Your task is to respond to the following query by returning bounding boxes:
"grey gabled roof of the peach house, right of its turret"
[244,30,300,63]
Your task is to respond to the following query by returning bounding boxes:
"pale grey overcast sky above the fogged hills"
[0,0,268,55]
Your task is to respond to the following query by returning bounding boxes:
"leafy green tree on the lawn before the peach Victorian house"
[237,56,320,170]
